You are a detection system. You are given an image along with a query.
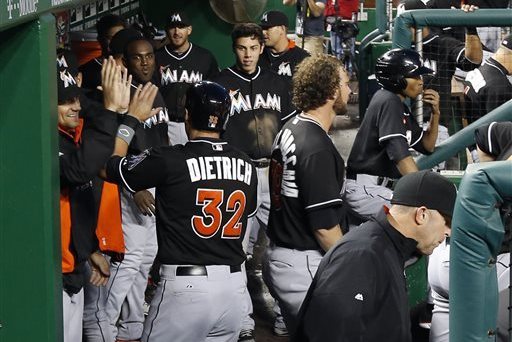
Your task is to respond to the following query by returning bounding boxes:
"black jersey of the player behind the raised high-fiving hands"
[128,83,169,154]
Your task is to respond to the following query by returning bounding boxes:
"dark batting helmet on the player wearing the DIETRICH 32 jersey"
[185,81,231,132]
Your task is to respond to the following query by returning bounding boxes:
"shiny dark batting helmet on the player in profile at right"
[375,49,434,93]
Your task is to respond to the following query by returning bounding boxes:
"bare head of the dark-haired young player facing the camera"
[231,23,264,74]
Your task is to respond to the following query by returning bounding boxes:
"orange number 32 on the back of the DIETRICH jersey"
[191,189,245,239]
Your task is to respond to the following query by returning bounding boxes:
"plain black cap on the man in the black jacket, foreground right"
[391,170,457,219]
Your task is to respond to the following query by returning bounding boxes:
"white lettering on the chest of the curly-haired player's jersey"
[273,129,299,198]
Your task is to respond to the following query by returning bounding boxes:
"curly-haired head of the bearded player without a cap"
[293,54,351,114]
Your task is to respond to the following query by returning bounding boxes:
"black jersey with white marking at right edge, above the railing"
[464,57,512,123]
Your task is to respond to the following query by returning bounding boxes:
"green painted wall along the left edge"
[0,14,62,342]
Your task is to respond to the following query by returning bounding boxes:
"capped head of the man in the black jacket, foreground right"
[391,170,457,255]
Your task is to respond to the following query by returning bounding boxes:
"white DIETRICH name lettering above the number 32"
[187,156,252,185]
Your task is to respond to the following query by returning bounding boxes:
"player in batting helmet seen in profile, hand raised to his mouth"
[345,49,440,223]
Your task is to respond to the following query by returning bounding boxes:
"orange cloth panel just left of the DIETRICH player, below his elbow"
[96,182,125,254]
